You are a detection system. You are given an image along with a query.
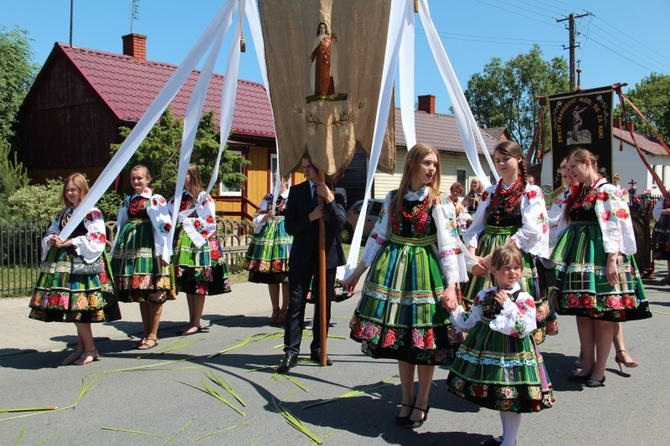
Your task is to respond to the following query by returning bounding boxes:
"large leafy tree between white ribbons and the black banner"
[465,44,569,151]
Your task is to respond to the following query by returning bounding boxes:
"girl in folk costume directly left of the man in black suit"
[246,176,293,325]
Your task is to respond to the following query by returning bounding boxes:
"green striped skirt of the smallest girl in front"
[447,320,555,413]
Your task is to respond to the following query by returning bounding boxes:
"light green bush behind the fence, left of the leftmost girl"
[7,178,63,221]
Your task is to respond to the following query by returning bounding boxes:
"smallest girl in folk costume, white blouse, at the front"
[447,244,554,446]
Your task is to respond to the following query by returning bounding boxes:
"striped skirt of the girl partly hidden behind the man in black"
[246,216,293,283]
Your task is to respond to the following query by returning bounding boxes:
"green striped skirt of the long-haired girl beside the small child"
[349,235,451,365]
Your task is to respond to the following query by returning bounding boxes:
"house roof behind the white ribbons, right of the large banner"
[395,109,500,155]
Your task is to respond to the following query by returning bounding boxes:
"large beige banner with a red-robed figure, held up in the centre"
[259,0,395,179]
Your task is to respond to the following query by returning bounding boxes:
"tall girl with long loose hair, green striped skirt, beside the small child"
[344,144,467,428]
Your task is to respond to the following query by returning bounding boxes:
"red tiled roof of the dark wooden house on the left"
[56,43,275,138]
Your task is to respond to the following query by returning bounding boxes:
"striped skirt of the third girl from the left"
[173,227,231,296]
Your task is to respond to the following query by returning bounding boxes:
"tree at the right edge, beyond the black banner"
[614,73,670,143]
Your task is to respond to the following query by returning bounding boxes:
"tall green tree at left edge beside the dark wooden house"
[0,26,39,141]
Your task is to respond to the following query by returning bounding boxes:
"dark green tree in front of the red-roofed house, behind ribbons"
[111,107,248,198]
